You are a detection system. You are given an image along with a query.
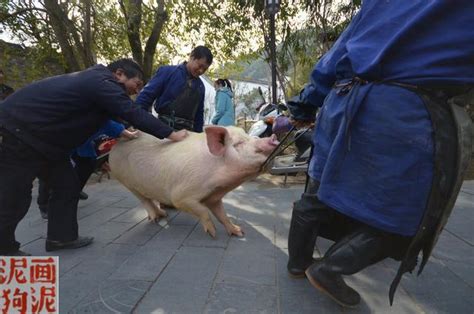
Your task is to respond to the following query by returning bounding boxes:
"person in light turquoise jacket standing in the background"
[211,79,235,126]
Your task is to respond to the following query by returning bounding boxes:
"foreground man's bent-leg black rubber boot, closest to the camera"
[306,228,387,307]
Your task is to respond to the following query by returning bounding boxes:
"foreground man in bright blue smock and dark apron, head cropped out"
[288,0,474,307]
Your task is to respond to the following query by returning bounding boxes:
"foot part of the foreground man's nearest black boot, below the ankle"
[306,262,360,307]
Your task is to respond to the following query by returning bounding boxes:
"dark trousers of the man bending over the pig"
[0,129,79,254]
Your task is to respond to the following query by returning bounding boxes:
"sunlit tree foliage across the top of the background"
[0,0,360,90]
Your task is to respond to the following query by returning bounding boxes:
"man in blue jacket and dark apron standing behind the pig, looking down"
[135,46,213,132]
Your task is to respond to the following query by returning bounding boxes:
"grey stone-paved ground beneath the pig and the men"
[17,175,474,314]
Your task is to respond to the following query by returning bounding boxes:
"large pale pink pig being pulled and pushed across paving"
[109,126,278,237]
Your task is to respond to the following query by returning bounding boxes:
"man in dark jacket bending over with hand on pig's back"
[0,59,187,255]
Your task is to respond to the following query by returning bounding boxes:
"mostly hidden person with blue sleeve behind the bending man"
[37,120,138,219]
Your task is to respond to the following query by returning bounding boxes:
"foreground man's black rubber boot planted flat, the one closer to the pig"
[287,179,327,278]
